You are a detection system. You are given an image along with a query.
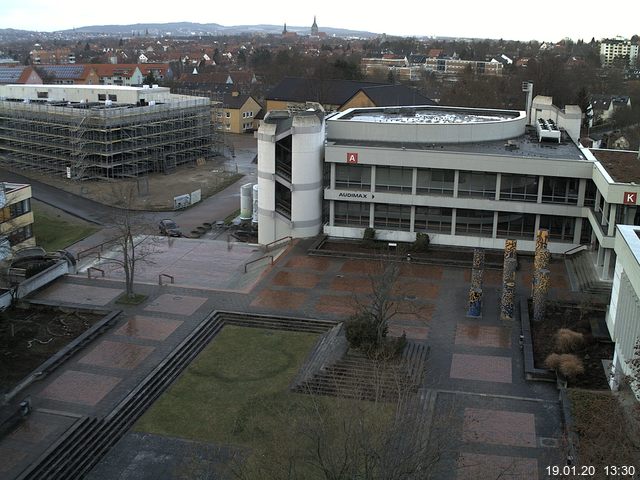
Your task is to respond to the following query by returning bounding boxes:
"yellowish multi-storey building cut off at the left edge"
[0,182,36,260]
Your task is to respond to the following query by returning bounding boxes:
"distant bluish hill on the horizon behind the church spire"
[59,22,377,38]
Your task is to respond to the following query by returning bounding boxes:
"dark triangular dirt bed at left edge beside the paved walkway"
[0,305,103,392]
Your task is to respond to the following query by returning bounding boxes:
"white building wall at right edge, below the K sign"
[607,225,640,399]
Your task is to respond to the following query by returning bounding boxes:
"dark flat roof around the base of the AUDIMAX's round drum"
[328,127,589,161]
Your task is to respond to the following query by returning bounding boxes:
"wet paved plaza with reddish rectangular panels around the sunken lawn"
[0,239,571,480]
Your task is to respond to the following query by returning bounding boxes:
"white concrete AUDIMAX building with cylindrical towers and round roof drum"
[258,97,640,279]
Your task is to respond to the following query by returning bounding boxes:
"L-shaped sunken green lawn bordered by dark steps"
[134,325,397,480]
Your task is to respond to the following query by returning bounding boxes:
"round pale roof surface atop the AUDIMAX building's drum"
[332,105,522,125]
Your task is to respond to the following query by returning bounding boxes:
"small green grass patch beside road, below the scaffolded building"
[32,202,98,252]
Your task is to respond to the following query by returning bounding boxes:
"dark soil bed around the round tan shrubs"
[529,302,613,390]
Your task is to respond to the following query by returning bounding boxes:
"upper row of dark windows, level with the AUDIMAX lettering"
[335,165,595,205]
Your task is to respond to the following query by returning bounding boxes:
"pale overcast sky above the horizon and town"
[0,0,640,41]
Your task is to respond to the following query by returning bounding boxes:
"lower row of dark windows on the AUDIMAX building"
[334,201,575,242]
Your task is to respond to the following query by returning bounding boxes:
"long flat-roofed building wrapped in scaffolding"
[0,85,213,180]
